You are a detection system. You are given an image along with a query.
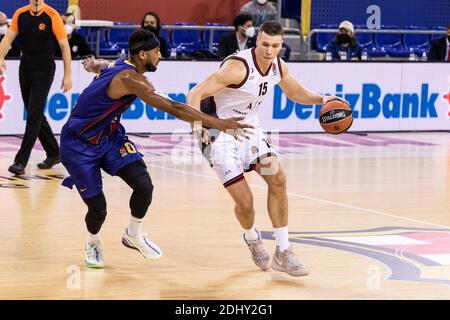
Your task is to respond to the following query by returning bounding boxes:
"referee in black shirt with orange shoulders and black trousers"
[0,0,72,175]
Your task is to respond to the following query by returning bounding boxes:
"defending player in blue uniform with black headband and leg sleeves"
[60,29,252,268]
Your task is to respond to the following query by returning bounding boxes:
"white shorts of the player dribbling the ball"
[203,128,278,187]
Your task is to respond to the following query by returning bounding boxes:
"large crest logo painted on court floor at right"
[262,227,450,285]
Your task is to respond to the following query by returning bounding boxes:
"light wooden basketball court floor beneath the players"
[0,132,450,299]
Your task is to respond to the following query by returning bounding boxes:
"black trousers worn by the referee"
[14,56,59,166]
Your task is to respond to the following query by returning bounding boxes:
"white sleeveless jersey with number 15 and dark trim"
[214,48,282,127]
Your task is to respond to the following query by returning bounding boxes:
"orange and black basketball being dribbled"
[319,99,353,134]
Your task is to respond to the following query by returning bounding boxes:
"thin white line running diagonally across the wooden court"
[149,164,450,229]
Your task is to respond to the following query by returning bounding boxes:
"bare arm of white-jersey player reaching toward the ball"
[279,61,348,105]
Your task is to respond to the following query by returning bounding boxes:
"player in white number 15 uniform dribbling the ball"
[187,21,342,276]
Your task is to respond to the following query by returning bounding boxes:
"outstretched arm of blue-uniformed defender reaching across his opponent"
[116,71,253,137]
